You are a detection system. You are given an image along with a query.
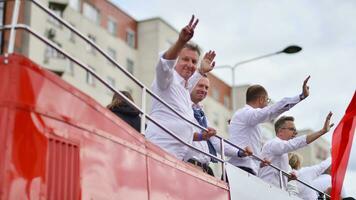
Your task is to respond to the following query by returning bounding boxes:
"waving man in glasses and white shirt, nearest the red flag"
[258,112,333,188]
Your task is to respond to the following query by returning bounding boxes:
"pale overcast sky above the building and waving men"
[113,0,356,197]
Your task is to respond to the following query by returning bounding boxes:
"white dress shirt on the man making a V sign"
[145,55,202,160]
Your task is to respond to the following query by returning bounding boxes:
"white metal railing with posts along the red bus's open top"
[0,0,330,199]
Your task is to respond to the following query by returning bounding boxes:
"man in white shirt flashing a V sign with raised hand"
[145,16,216,160]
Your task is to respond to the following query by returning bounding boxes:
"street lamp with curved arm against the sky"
[215,45,302,111]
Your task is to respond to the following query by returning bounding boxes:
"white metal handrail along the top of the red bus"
[0,0,330,197]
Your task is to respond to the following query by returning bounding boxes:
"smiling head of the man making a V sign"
[175,43,200,80]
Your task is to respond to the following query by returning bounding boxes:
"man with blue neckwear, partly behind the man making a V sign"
[184,76,252,176]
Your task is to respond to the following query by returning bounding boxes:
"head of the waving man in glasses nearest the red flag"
[274,116,297,140]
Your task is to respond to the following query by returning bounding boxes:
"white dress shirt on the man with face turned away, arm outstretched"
[229,96,300,174]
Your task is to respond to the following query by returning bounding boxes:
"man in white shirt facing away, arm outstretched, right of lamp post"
[229,76,310,175]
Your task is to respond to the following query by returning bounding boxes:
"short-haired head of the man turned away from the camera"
[246,85,271,108]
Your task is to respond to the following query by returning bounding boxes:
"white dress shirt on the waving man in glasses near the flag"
[258,135,307,188]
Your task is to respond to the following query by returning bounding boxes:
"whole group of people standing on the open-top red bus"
[108,16,352,199]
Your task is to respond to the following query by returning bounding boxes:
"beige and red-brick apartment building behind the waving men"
[3,0,232,137]
